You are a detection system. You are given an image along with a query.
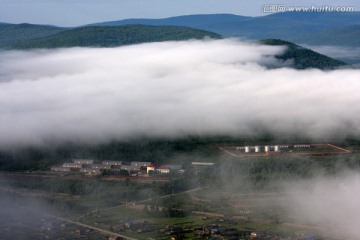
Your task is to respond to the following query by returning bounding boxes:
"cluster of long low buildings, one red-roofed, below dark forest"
[51,159,184,175]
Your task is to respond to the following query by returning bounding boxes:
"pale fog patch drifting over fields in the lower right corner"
[288,172,360,239]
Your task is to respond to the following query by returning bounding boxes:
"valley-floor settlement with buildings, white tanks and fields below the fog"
[3,143,350,240]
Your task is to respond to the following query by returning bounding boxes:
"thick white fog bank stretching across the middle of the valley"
[0,39,360,147]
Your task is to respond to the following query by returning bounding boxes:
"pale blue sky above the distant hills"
[0,0,360,27]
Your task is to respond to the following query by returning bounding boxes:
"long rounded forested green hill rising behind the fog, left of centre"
[11,25,221,49]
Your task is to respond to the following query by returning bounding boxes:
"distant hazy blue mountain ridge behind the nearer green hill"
[92,12,360,46]
